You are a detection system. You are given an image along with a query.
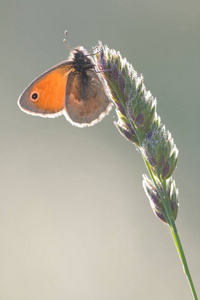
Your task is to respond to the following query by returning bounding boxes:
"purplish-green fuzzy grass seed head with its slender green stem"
[95,42,198,299]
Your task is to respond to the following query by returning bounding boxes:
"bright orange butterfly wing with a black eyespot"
[18,61,73,117]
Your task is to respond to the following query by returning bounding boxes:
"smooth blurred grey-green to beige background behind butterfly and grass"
[0,0,200,300]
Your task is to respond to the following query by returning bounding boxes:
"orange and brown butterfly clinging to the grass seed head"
[18,40,112,127]
